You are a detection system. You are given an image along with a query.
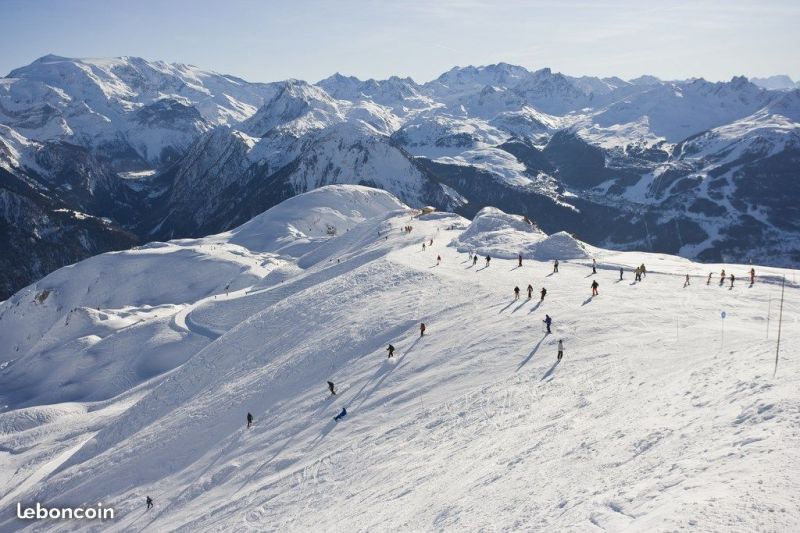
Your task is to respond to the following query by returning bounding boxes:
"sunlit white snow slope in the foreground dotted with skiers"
[0,186,800,532]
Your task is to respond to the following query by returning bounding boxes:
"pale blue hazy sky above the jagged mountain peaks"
[0,0,800,81]
